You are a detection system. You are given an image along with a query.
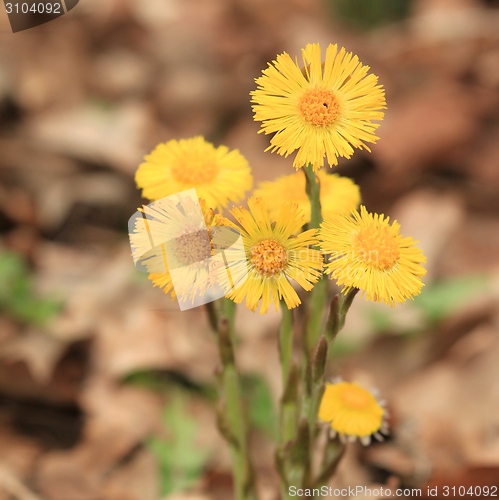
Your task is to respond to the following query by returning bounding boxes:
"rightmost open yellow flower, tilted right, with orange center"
[319,206,426,306]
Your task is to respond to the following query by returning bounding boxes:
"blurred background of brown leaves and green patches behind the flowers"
[0,0,499,500]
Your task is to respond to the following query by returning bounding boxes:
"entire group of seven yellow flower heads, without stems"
[130,43,426,450]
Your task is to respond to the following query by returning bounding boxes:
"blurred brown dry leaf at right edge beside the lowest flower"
[389,318,499,477]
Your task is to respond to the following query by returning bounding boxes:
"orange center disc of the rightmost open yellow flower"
[354,227,400,269]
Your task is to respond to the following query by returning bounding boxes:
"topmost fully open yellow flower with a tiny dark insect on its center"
[251,43,386,171]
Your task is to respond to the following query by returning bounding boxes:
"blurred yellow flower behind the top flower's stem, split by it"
[254,170,360,222]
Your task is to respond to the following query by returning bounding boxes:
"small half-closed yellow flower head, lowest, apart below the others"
[319,381,388,444]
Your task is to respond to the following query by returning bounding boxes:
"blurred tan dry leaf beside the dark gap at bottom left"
[36,377,161,500]
